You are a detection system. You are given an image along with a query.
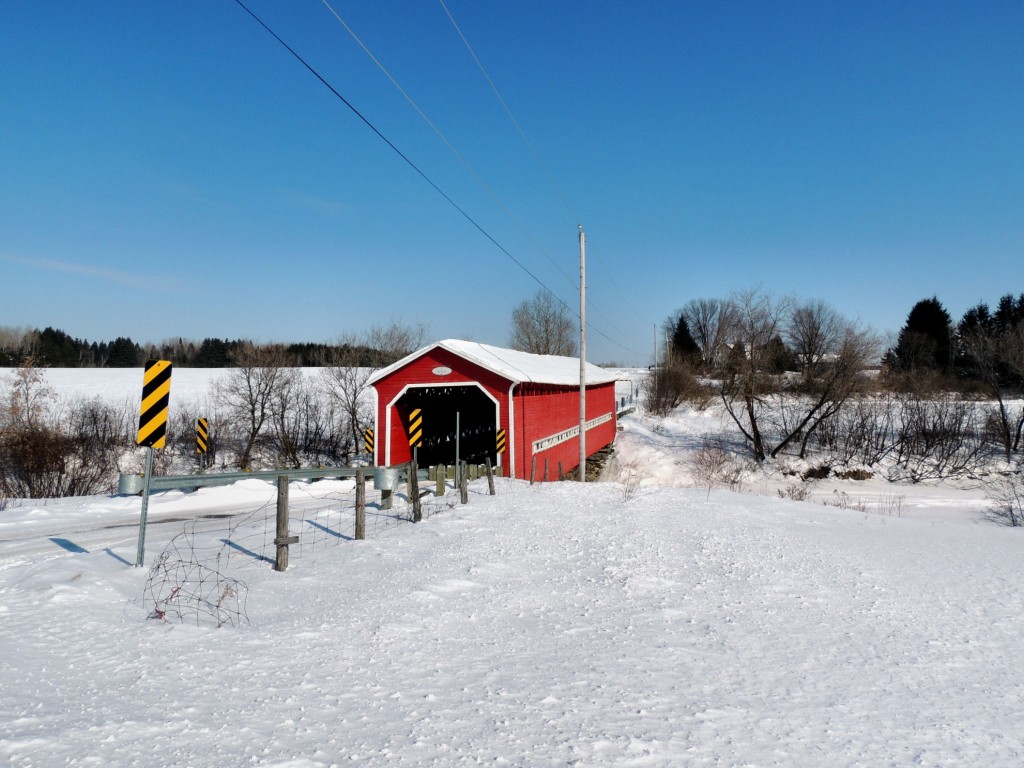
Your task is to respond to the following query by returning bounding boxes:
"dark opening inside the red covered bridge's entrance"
[396,385,498,467]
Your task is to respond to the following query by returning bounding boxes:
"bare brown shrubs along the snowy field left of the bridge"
[0,323,425,501]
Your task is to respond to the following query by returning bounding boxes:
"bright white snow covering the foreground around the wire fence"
[0,372,1024,768]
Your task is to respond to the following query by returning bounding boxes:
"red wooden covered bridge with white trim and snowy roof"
[370,339,615,479]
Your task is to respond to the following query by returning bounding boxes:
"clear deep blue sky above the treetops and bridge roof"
[0,0,1024,365]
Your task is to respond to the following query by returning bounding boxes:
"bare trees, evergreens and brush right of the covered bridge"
[644,290,1024,468]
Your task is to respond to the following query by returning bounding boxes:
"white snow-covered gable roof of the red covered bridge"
[370,339,621,386]
